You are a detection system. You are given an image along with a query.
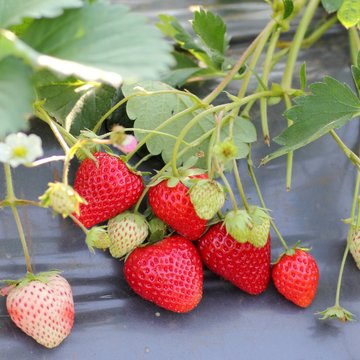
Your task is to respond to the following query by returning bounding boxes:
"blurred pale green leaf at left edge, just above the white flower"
[0,57,34,138]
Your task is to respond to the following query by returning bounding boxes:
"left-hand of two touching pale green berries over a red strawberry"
[224,209,253,243]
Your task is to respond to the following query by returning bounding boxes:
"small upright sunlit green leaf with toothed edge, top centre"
[192,8,228,65]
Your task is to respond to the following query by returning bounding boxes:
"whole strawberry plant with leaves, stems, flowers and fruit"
[0,0,360,347]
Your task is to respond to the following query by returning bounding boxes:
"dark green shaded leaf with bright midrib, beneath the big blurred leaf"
[36,71,115,135]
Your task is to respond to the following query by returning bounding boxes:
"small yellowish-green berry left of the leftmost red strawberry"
[39,182,86,218]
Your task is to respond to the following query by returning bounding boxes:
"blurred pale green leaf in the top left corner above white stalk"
[0,0,83,28]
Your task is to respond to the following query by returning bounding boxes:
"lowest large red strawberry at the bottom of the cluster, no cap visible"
[124,235,203,313]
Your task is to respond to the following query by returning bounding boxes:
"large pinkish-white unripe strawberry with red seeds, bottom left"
[1,271,74,348]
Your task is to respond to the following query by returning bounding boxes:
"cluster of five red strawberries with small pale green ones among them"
[74,152,319,313]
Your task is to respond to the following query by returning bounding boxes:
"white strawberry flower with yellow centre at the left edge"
[0,132,43,167]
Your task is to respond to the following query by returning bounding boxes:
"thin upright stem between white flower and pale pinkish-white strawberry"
[4,164,33,273]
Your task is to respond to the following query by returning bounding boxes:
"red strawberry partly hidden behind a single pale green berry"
[149,174,207,240]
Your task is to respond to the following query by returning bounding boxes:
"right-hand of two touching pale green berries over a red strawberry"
[248,206,270,247]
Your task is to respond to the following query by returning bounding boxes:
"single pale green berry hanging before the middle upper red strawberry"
[189,179,225,220]
